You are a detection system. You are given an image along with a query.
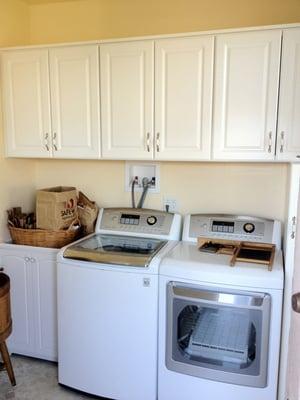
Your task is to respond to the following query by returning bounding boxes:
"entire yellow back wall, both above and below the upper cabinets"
[26,0,300,225]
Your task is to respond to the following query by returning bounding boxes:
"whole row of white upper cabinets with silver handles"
[1,27,300,161]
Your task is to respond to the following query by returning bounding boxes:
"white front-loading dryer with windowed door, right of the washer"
[158,214,284,400]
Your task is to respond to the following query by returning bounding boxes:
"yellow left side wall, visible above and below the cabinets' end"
[0,0,35,241]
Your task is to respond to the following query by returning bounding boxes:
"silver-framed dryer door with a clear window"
[166,282,271,387]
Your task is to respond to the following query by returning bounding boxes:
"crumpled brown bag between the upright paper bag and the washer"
[78,192,99,235]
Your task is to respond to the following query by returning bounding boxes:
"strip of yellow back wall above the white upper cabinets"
[31,0,300,43]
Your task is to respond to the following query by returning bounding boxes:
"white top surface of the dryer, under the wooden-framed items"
[159,242,284,290]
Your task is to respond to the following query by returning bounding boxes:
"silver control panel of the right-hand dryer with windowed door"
[183,214,281,248]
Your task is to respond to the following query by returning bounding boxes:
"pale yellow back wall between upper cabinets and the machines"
[37,160,288,220]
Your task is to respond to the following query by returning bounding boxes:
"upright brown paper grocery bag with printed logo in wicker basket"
[36,186,78,230]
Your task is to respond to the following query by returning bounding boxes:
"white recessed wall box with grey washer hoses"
[125,162,160,193]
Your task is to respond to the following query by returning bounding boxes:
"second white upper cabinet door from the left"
[49,45,100,159]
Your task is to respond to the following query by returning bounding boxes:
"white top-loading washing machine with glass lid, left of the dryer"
[58,209,181,400]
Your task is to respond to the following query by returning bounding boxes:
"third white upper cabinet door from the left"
[100,41,154,160]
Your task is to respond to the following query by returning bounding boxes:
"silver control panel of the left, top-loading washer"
[100,208,174,235]
